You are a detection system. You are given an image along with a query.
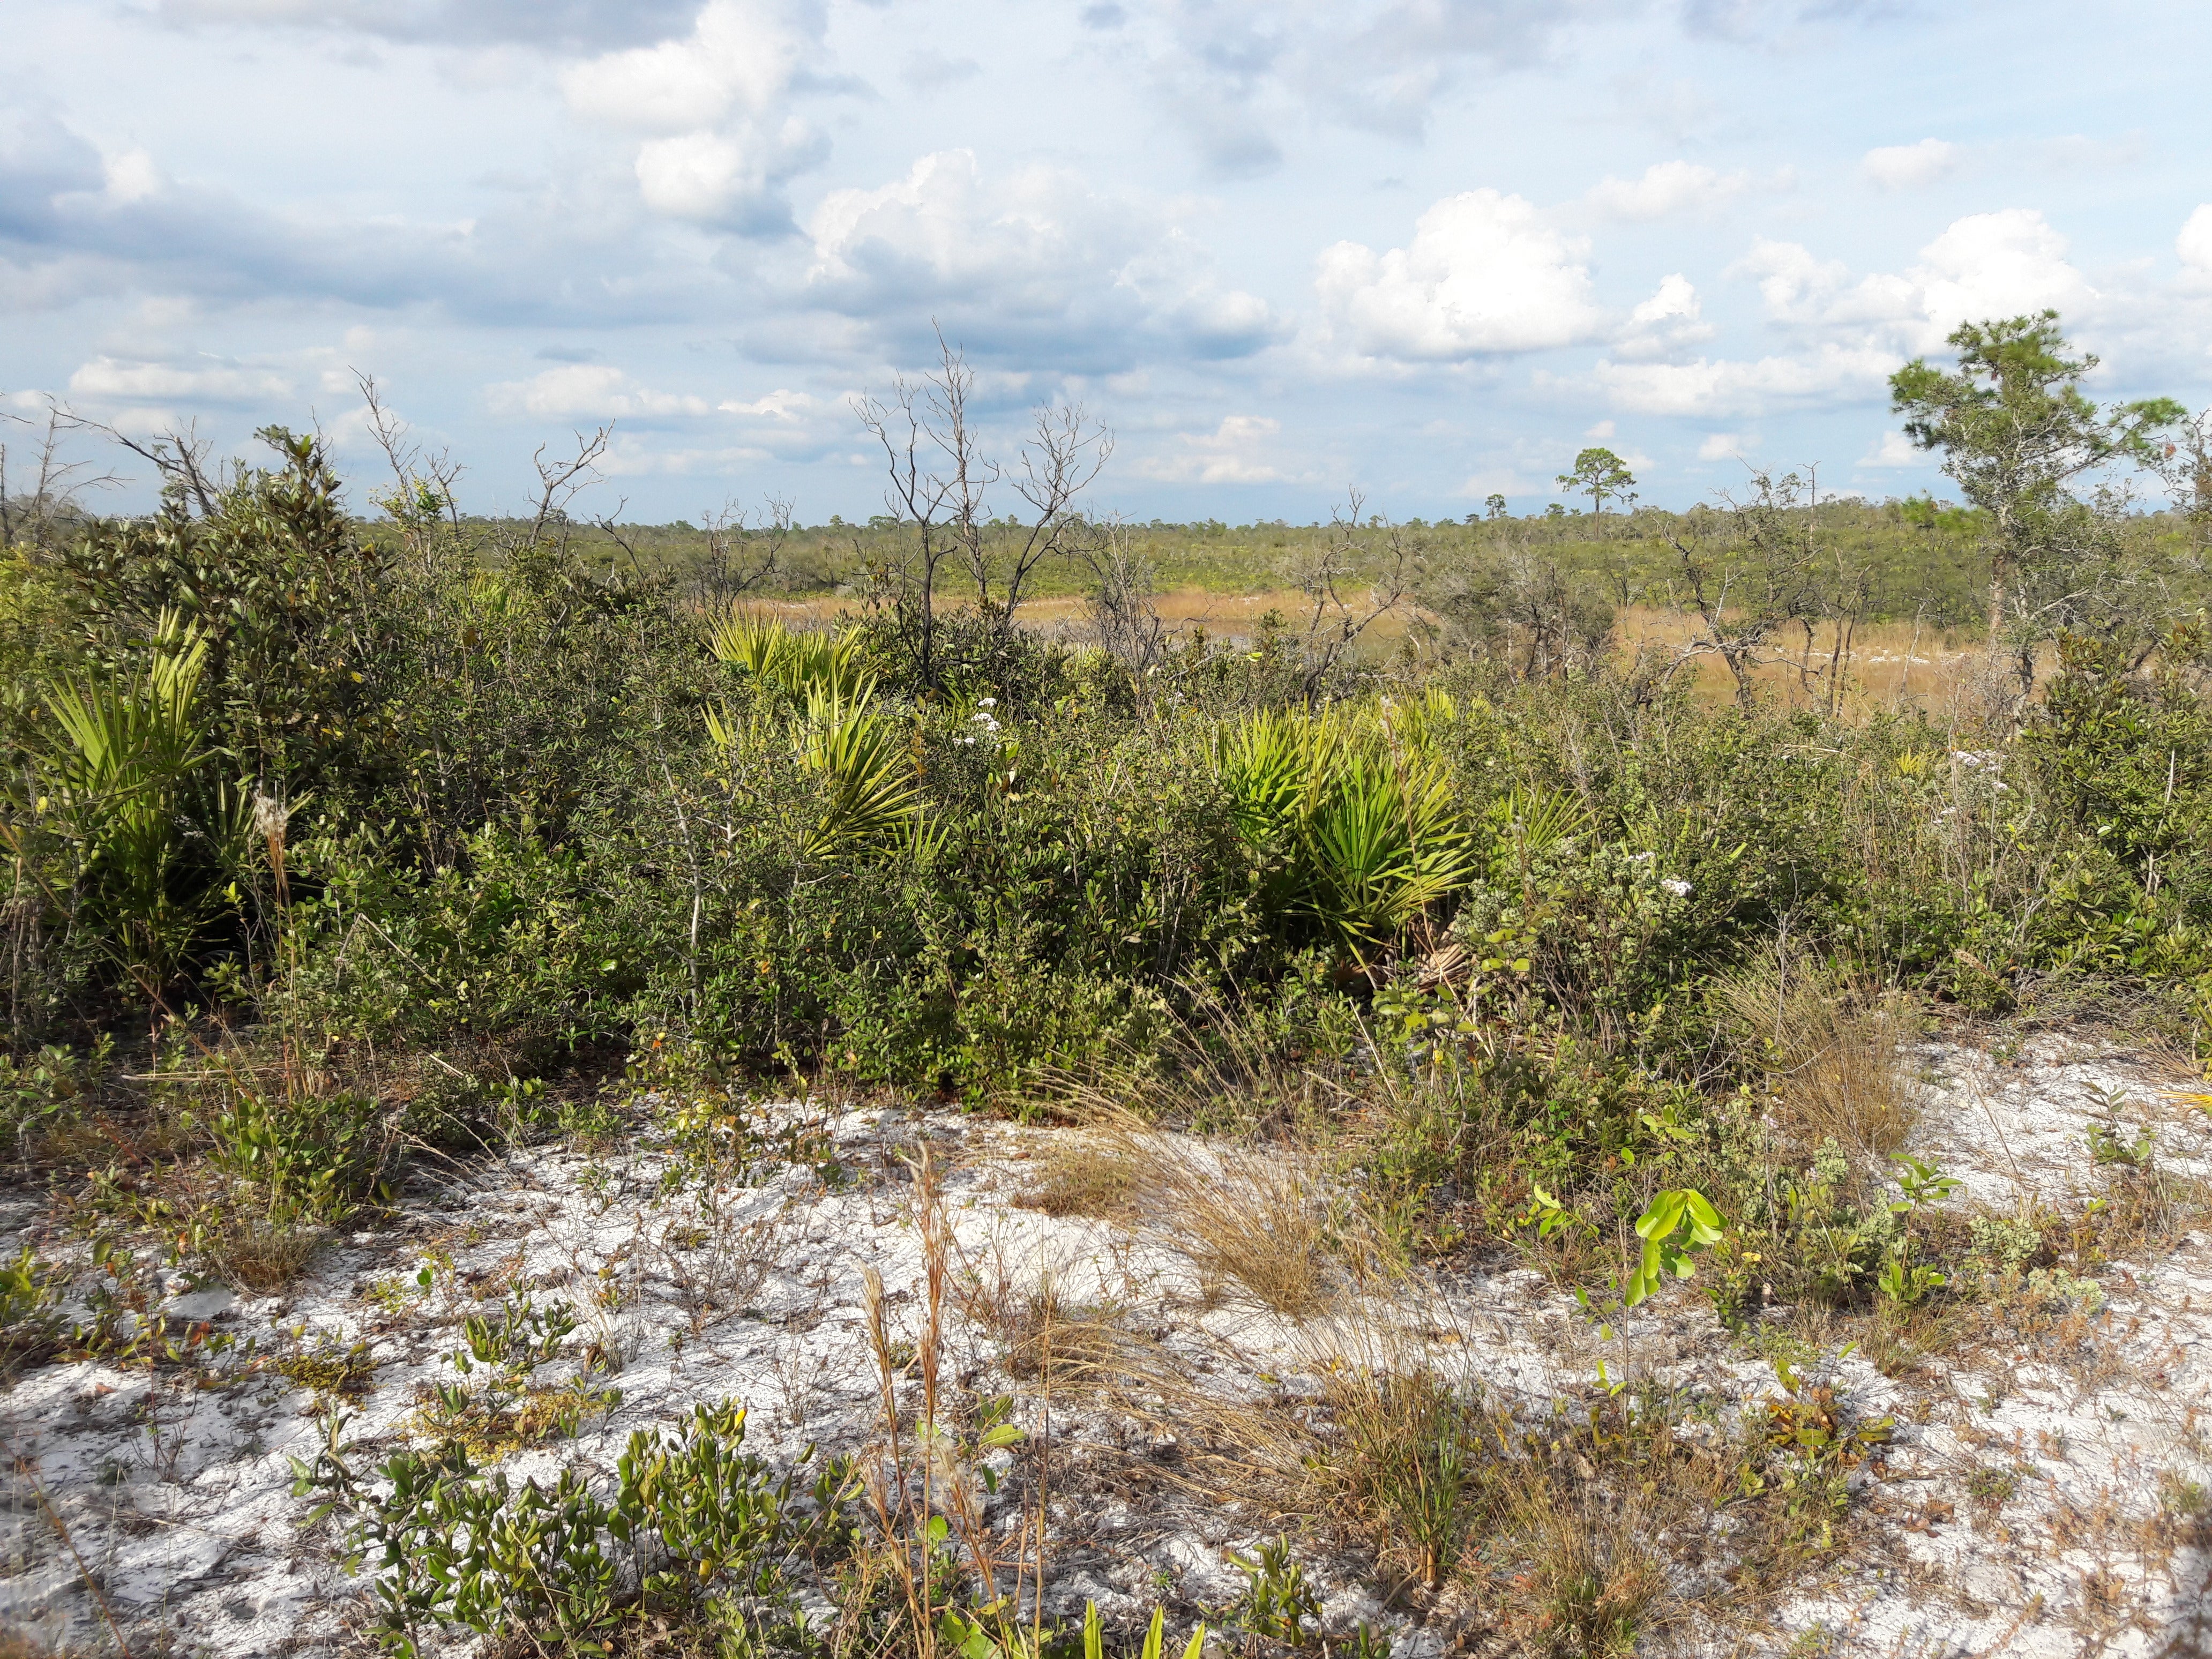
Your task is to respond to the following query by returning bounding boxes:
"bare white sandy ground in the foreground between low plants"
[0,1042,2212,1659]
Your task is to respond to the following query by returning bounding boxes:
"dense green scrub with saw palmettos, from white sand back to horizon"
[0,312,2212,1659]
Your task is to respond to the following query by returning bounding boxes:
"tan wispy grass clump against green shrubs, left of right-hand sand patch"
[1718,965,1918,1163]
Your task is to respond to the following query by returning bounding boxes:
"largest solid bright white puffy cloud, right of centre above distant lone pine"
[1314,190,1604,363]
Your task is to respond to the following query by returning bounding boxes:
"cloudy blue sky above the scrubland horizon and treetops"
[0,0,2212,522]
